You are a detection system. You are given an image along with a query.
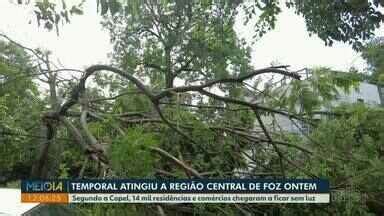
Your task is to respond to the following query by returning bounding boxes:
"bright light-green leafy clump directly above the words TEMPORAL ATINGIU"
[110,128,159,178]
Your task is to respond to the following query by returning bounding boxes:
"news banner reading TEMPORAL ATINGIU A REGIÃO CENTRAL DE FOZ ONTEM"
[21,179,330,203]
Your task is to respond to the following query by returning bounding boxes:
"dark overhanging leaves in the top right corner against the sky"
[287,0,384,49]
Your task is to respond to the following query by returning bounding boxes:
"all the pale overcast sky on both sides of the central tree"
[0,0,384,70]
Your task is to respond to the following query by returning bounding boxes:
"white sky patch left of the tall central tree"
[0,0,112,69]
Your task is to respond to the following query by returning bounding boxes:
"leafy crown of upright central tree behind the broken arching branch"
[103,1,250,88]
